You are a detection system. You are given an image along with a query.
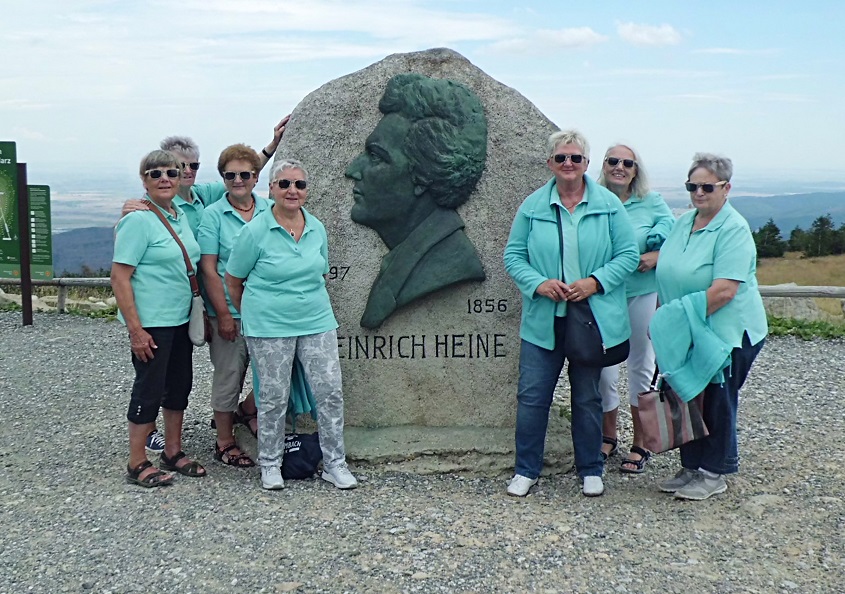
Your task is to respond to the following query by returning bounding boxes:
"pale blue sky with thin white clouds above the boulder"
[0,0,845,186]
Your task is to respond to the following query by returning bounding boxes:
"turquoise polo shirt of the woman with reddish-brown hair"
[197,194,273,318]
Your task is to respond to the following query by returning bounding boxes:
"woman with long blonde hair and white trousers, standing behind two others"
[597,144,675,474]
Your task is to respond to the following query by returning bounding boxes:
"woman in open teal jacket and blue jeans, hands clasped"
[504,130,639,497]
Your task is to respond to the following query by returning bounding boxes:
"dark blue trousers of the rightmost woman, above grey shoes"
[681,333,766,474]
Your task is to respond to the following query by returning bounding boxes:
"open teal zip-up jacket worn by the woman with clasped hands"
[504,176,640,350]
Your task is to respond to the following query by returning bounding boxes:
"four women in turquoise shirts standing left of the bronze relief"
[112,118,357,489]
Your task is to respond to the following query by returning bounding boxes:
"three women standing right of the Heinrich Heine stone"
[504,131,767,500]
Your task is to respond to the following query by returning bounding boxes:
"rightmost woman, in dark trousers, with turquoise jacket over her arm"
[651,153,768,500]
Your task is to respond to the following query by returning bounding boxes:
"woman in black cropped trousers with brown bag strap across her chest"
[111,150,205,487]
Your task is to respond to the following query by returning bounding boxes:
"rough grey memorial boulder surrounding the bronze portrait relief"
[276,49,556,428]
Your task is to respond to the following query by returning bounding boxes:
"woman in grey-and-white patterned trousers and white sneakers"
[225,160,358,489]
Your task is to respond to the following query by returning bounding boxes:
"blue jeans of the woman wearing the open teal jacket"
[515,317,604,479]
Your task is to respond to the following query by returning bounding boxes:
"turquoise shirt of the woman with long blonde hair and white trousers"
[623,192,675,297]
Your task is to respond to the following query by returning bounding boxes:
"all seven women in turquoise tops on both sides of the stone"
[112,118,767,500]
